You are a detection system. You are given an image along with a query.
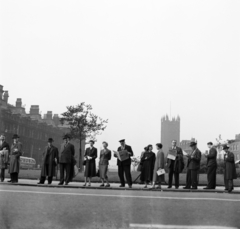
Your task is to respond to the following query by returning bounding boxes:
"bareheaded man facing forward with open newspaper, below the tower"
[167,140,184,189]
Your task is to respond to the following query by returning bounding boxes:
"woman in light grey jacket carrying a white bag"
[152,143,165,189]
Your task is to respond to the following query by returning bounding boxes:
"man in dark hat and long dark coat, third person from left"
[38,138,58,184]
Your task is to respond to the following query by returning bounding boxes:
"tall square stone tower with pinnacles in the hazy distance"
[161,115,180,154]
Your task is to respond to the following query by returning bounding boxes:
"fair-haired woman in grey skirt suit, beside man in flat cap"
[99,142,112,187]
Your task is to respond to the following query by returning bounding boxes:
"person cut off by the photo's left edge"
[0,134,10,182]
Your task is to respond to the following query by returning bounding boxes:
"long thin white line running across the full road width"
[0,190,240,202]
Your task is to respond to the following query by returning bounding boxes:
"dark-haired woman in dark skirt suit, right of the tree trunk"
[83,140,97,186]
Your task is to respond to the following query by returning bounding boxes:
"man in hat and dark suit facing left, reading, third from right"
[184,142,201,189]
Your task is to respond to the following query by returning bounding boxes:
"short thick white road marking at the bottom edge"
[130,224,237,229]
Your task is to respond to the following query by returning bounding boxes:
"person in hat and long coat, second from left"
[9,134,22,183]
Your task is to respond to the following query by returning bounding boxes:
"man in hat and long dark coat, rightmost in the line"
[223,145,237,193]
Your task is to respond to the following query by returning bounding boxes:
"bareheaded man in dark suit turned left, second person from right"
[204,142,217,189]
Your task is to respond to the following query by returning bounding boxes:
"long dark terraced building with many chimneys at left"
[0,85,85,165]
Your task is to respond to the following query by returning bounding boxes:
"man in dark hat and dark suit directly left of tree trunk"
[58,134,75,185]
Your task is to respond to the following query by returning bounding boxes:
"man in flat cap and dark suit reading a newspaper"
[114,139,133,188]
